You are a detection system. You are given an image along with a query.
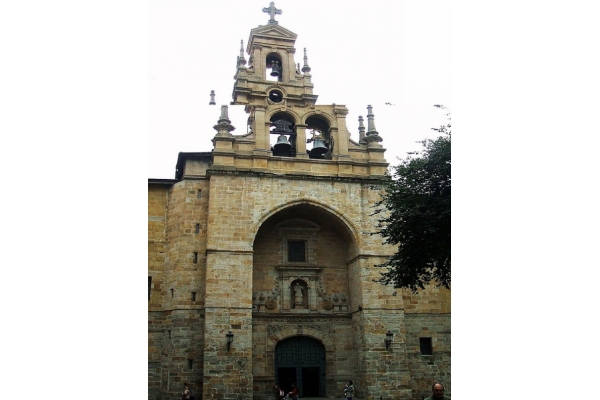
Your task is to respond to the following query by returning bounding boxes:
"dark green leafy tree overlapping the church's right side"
[374,105,451,293]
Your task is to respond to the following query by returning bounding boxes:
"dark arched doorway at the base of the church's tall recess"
[275,336,325,397]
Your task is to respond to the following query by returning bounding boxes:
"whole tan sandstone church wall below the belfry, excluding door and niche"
[148,171,450,400]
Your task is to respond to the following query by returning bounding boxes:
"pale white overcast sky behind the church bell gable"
[148,0,451,178]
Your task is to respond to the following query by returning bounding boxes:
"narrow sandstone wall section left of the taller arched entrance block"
[148,180,208,399]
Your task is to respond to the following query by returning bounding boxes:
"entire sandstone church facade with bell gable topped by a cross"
[148,3,450,400]
